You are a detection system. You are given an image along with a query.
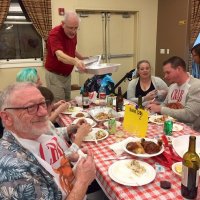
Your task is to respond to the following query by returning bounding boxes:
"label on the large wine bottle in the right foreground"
[181,165,199,187]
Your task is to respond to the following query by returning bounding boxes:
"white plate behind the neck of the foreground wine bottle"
[172,135,200,158]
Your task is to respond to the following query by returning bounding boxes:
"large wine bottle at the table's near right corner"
[181,136,200,199]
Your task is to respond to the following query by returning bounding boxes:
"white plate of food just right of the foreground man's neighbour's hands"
[83,128,109,142]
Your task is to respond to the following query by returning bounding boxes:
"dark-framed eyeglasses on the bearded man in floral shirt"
[4,100,48,115]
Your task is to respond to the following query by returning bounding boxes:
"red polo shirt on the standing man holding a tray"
[45,25,77,76]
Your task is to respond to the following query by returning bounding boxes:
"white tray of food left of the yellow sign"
[88,106,119,122]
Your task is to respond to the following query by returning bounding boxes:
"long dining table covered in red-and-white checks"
[57,103,200,200]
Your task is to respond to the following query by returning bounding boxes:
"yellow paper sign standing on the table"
[123,105,148,137]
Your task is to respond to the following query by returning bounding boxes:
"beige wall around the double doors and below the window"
[0,0,158,93]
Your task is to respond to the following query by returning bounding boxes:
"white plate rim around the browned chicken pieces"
[124,138,164,158]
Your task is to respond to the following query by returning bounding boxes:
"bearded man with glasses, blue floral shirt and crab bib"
[0,83,95,200]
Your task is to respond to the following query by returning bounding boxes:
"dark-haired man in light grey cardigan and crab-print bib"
[147,56,200,131]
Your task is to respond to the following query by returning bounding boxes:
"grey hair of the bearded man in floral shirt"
[0,82,36,111]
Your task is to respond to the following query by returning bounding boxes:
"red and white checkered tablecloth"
[58,114,200,200]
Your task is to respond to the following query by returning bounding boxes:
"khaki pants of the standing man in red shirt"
[45,70,71,102]
